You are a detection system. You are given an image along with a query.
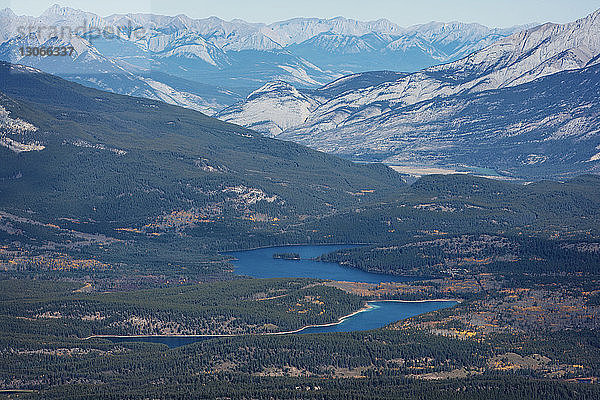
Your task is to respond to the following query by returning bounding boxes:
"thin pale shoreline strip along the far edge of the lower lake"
[82,299,463,340]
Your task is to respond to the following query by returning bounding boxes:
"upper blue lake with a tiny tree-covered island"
[227,245,415,283]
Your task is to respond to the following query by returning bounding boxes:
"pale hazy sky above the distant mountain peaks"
[0,0,600,27]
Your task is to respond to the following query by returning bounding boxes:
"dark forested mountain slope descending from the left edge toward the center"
[0,63,402,228]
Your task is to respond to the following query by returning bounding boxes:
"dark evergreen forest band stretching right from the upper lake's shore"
[319,234,600,276]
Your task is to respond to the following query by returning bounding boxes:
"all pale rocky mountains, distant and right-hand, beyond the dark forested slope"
[0,6,600,179]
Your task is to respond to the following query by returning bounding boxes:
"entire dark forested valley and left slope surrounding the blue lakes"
[0,63,600,400]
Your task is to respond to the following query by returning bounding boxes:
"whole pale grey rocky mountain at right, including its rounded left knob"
[218,10,600,178]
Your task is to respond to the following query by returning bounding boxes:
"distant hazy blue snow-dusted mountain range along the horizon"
[0,5,523,115]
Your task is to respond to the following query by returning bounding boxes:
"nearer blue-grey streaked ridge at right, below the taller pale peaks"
[279,65,600,179]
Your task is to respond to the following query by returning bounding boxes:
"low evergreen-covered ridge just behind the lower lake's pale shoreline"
[0,279,365,338]
